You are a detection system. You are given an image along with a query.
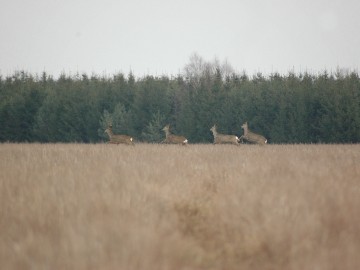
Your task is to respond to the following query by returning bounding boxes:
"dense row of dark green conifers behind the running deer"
[0,55,360,143]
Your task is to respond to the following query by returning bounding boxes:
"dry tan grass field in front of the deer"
[0,144,360,270]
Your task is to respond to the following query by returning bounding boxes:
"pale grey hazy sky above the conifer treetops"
[0,0,360,76]
